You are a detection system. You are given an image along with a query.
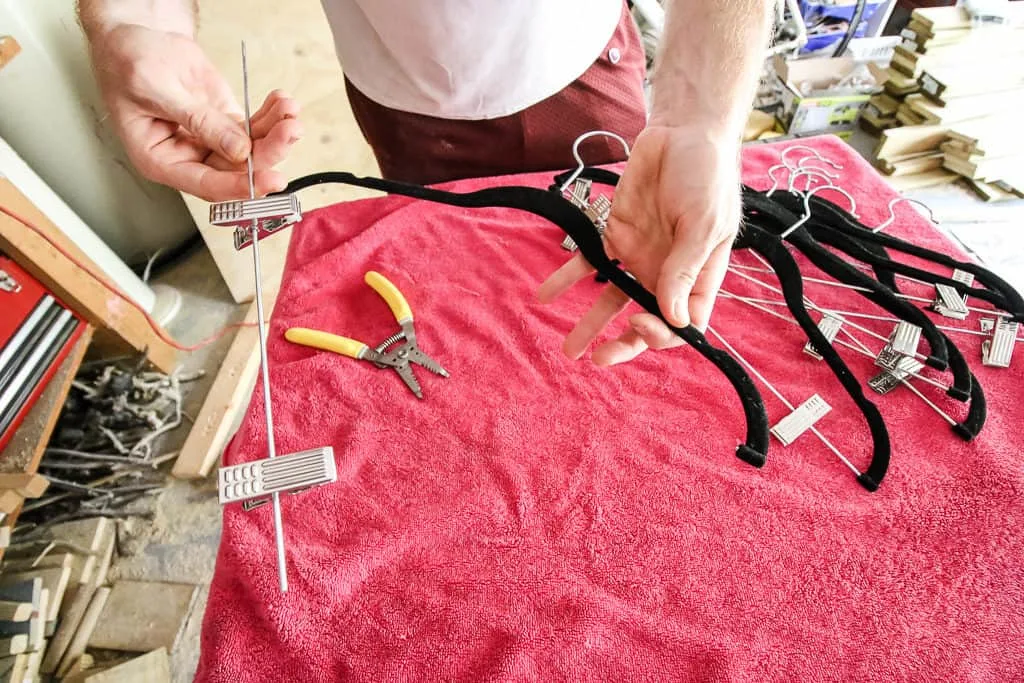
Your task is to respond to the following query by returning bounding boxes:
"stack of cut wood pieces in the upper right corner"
[861,4,1024,201]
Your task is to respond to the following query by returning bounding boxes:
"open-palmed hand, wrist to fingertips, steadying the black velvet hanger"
[538,125,741,366]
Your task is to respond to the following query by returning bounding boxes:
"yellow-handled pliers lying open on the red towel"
[285,270,449,398]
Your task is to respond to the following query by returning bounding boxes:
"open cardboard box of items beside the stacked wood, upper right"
[774,55,887,135]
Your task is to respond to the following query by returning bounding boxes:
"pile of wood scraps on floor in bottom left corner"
[0,517,182,683]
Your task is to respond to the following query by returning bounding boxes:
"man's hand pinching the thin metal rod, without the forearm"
[91,25,302,202]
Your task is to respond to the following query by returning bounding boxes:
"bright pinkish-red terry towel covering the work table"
[197,137,1024,683]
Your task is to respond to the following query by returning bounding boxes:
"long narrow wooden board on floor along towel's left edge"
[171,286,279,479]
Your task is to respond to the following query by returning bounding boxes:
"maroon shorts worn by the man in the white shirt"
[345,2,647,184]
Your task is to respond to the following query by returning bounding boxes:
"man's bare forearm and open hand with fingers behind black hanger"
[540,0,774,365]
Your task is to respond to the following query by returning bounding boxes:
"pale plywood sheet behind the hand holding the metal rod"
[184,0,379,302]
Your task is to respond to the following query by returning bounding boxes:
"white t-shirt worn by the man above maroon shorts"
[322,0,623,119]
